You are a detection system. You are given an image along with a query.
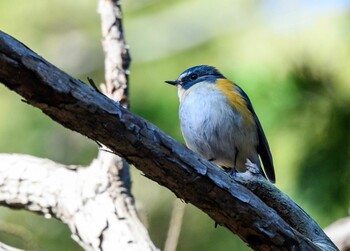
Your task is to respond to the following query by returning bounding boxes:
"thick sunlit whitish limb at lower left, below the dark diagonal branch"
[0,154,156,250]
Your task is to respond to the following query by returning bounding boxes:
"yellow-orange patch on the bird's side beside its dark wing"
[216,78,254,125]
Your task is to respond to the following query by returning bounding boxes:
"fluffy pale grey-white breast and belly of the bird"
[179,85,257,170]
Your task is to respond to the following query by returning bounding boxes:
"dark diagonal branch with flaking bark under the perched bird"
[0,33,337,250]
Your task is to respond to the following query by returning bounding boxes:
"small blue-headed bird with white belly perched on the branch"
[165,65,276,183]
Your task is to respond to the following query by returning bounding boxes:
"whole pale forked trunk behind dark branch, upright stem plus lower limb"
[0,0,157,250]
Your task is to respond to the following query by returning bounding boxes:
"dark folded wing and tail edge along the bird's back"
[235,84,276,183]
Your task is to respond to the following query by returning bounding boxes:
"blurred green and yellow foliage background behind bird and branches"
[0,0,350,251]
